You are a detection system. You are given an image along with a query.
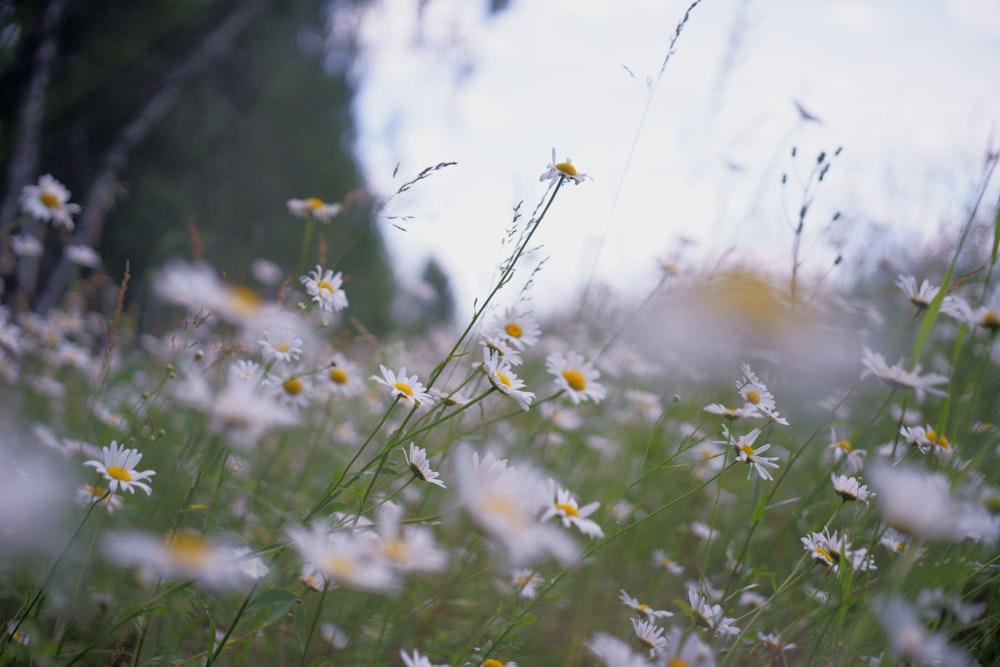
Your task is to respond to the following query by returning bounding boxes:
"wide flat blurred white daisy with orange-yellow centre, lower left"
[103,531,257,589]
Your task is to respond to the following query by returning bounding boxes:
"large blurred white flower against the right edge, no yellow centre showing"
[868,464,1000,545]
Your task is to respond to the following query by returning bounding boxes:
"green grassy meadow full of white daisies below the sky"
[0,145,1000,667]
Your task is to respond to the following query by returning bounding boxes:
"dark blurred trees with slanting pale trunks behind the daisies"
[0,0,393,332]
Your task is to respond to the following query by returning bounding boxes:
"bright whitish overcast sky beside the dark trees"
[340,0,1000,319]
